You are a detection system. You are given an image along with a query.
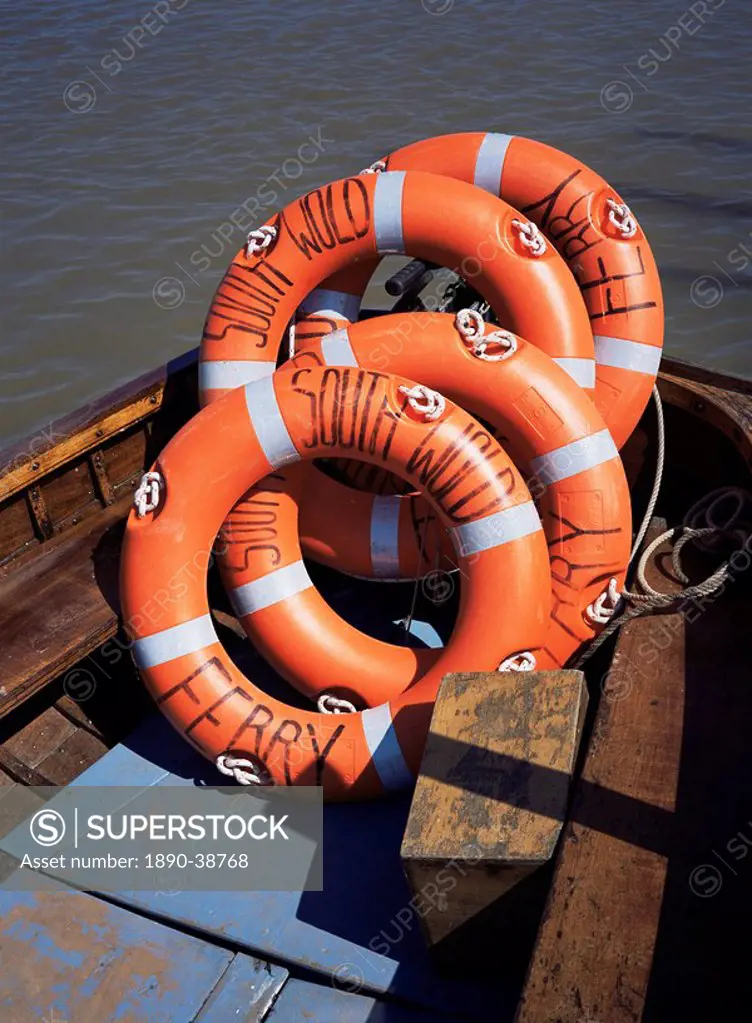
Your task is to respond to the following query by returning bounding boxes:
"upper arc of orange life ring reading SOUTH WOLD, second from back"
[198,171,592,404]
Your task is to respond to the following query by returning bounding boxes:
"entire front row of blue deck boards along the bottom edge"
[0,883,446,1023]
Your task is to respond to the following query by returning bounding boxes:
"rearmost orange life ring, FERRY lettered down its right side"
[301,132,664,448]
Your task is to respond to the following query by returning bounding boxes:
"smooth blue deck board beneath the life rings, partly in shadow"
[83,716,505,1018]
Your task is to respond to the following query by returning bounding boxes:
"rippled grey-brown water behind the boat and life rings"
[0,0,752,441]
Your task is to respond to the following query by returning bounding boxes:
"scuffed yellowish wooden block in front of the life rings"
[402,670,587,945]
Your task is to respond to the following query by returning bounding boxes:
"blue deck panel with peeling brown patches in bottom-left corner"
[0,882,233,1023]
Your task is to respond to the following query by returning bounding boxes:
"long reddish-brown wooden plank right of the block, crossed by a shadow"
[517,520,685,1023]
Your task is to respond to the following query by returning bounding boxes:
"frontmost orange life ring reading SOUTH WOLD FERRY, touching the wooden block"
[121,366,549,799]
